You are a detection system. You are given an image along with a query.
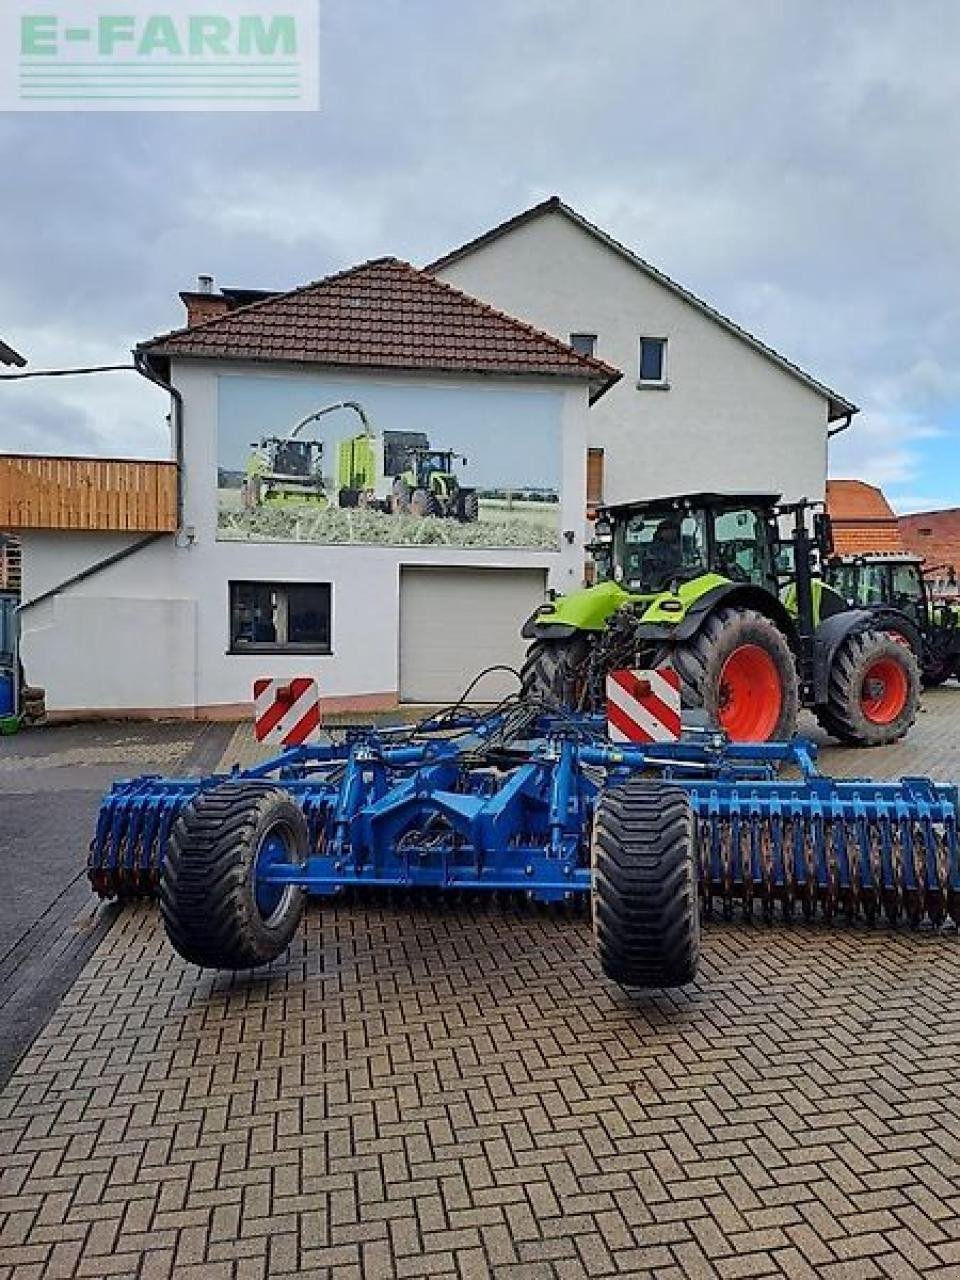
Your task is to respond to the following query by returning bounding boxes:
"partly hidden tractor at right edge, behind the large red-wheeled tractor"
[826,552,960,685]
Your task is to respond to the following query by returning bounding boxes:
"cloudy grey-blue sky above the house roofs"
[0,0,960,511]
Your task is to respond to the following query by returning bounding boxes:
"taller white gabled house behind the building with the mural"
[426,196,856,502]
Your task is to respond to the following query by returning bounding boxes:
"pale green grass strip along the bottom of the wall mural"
[218,489,558,550]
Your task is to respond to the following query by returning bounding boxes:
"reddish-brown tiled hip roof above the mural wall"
[137,257,622,401]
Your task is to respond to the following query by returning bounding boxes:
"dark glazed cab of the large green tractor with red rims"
[590,494,778,595]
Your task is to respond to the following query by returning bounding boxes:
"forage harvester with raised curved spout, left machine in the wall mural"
[241,401,370,511]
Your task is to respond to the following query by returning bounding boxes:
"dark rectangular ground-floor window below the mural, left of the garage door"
[230,582,333,653]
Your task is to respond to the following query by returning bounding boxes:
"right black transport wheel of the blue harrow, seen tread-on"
[593,780,700,987]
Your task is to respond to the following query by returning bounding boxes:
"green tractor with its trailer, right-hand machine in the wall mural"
[337,431,480,521]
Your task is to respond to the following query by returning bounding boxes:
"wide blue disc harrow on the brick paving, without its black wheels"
[88,708,960,936]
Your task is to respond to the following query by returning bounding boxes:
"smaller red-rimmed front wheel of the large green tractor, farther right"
[815,631,920,746]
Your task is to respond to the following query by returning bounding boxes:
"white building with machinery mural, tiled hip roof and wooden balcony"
[15,259,620,717]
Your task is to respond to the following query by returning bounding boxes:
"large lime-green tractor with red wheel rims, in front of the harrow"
[522,493,920,746]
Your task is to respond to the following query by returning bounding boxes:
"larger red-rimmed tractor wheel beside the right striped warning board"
[672,608,799,742]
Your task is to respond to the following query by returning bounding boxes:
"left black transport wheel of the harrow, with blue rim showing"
[160,782,307,969]
